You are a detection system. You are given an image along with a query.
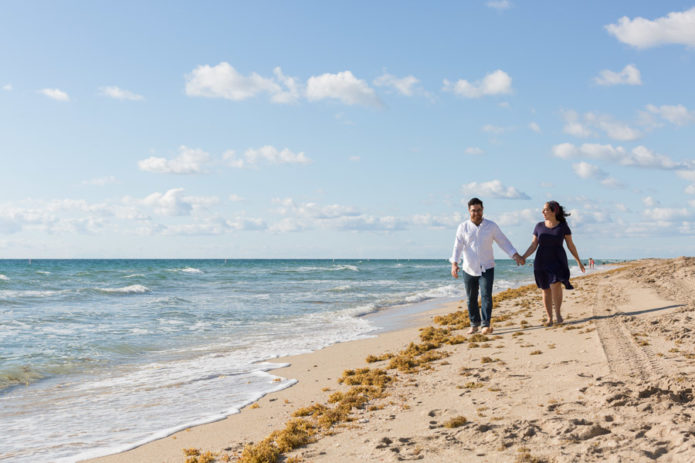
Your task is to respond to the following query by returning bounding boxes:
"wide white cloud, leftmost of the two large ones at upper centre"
[186,62,300,103]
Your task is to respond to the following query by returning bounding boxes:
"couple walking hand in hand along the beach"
[449,198,584,334]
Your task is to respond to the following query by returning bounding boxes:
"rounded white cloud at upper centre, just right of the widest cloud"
[306,71,381,107]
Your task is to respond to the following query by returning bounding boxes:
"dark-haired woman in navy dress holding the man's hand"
[521,201,584,326]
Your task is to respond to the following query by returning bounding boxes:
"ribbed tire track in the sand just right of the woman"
[592,281,663,380]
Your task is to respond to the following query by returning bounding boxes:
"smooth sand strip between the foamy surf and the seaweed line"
[78,264,648,462]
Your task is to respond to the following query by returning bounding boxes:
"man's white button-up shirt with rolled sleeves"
[449,219,517,276]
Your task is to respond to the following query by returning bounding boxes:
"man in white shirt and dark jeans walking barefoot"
[449,198,525,334]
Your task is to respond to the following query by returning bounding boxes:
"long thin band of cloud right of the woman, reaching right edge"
[552,143,695,171]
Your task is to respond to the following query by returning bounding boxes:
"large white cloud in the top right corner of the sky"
[605,8,695,48]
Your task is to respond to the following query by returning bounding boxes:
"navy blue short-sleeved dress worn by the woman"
[533,222,574,289]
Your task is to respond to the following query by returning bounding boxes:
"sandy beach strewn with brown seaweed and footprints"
[89,257,695,463]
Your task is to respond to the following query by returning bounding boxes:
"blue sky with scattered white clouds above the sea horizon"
[0,0,695,259]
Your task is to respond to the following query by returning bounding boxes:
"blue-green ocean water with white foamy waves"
[0,259,600,462]
